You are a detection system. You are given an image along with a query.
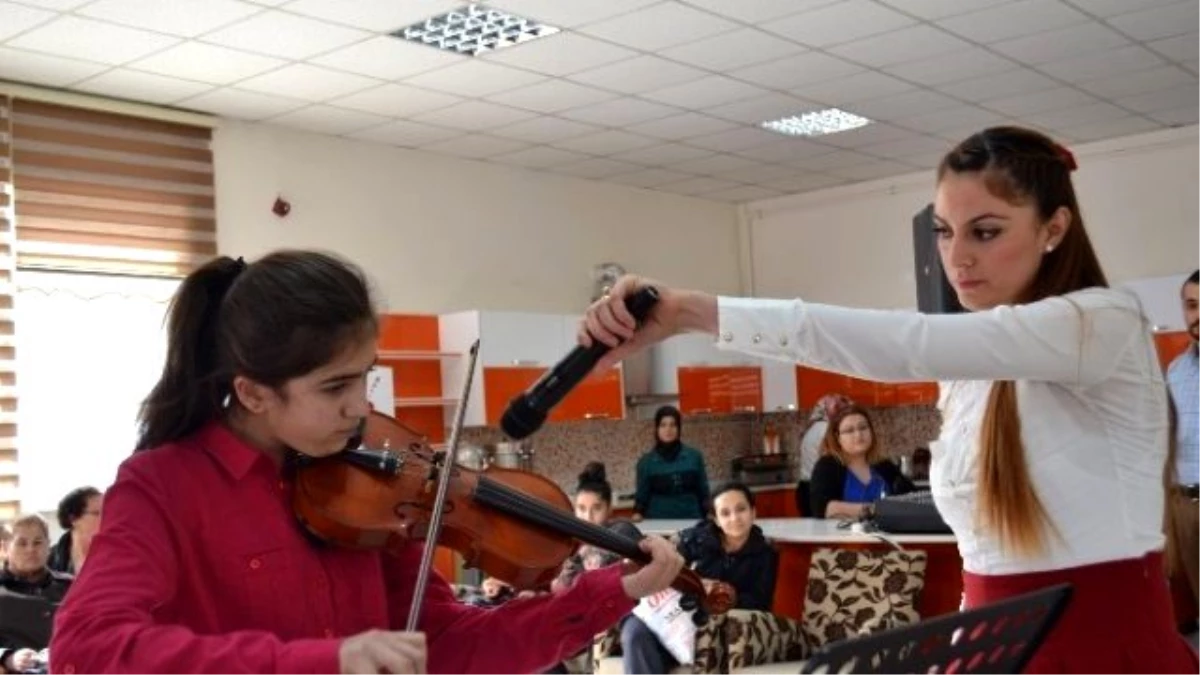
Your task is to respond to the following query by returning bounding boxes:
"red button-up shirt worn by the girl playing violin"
[50,424,635,675]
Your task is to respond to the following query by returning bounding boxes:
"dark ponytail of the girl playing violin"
[136,256,246,452]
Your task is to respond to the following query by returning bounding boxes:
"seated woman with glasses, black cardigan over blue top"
[810,406,913,519]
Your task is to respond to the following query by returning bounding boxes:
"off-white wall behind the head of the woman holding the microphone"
[746,126,1200,307]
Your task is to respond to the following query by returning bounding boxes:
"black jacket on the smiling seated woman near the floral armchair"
[678,520,779,611]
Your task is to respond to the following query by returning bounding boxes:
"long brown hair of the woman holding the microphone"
[937,126,1109,555]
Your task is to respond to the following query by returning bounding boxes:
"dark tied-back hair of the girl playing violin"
[137,250,378,450]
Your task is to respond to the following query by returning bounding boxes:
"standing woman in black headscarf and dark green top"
[634,406,708,520]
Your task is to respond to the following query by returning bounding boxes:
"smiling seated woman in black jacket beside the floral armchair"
[620,483,779,675]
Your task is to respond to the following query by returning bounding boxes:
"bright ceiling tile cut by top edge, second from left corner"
[76,0,263,37]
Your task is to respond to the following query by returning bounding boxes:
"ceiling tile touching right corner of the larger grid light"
[580,2,738,52]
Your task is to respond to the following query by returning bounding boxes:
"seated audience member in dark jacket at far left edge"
[0,515,71,673]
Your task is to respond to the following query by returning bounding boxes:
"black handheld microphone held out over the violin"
[500,286,659,441]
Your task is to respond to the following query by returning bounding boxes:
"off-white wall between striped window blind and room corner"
[214,121,740,312]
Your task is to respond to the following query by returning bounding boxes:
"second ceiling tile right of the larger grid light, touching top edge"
[761,0,917,47]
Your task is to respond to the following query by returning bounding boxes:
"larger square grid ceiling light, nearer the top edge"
[390,4,559,56]
